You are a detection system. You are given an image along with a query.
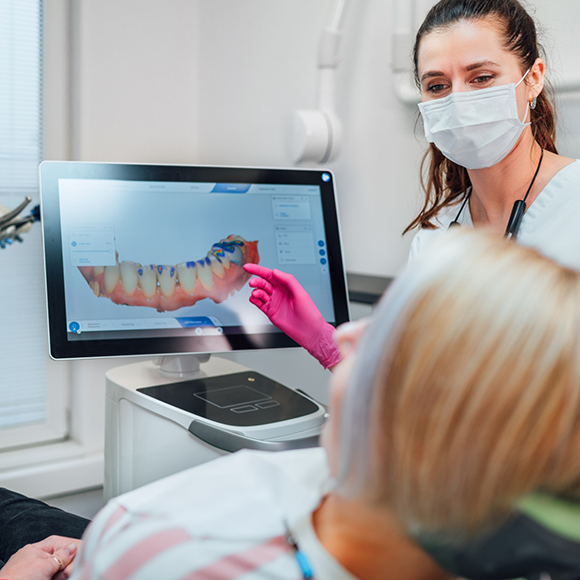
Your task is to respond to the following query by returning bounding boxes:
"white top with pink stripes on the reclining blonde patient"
[72,448,354,580]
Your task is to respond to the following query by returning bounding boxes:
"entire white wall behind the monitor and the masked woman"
[53,0,580,275]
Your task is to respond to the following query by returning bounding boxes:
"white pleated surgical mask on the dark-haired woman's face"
[419,69,530,169]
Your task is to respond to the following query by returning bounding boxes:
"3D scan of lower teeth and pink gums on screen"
[79,235,260,312]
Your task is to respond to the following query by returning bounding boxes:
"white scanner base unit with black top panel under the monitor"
[104,356,326,500]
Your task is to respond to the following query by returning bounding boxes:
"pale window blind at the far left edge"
[0,0,47,430]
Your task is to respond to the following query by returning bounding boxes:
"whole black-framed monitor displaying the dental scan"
[40,161,348,359]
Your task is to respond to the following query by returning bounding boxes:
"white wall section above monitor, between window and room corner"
[73,0,200,163]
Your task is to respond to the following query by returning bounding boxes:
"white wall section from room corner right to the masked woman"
[199,0,421,275]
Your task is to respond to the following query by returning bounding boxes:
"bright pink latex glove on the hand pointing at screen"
[244,264,342,369]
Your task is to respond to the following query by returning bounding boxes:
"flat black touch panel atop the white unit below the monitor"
[137,371,318,427]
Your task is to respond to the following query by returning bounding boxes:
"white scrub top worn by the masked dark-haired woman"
[409,160,580,270]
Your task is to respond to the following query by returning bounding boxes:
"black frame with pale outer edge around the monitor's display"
[40,161,349,360]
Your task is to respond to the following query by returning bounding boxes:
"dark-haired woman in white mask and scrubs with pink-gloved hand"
[245,0,580,368]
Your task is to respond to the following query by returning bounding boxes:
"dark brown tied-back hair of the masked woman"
[404,0,557,233]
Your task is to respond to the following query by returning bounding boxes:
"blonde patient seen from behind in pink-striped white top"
[0,231,580,580]
